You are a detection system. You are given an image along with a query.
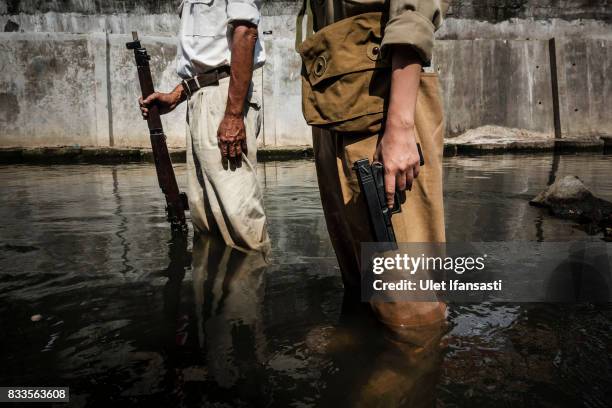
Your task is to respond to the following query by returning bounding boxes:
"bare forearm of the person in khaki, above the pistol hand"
[387,46,421,128]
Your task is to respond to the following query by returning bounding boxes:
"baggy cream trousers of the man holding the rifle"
[187,68,269,249]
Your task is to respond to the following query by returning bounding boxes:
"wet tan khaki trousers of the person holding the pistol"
[313,73,445,338]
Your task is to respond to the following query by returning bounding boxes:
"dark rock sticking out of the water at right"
[529,176,612,236]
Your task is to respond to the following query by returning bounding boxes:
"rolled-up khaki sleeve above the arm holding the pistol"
[382,0,448,64]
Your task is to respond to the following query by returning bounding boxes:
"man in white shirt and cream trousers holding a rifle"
[140,0,269,251]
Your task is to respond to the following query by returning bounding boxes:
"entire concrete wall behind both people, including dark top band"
[0,0,612,147]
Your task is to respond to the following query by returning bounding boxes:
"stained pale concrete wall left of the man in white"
[0,33,185,147]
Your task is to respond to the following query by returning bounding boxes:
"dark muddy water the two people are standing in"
[0,155,612,407]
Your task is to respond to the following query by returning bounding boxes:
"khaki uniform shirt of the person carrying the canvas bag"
[309,0,449,63]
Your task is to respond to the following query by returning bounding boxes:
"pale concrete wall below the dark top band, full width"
[0,33,612,147]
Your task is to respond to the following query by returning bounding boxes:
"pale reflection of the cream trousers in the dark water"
[193,235,266,388]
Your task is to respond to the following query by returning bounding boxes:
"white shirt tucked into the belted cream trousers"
[176,0,266,79]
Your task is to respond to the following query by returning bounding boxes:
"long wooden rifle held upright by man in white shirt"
[125,31,189,231]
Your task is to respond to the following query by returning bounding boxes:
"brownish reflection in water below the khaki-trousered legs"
[308,299,443,407]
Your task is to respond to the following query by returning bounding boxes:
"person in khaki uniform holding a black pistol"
[311,0,447,343]
